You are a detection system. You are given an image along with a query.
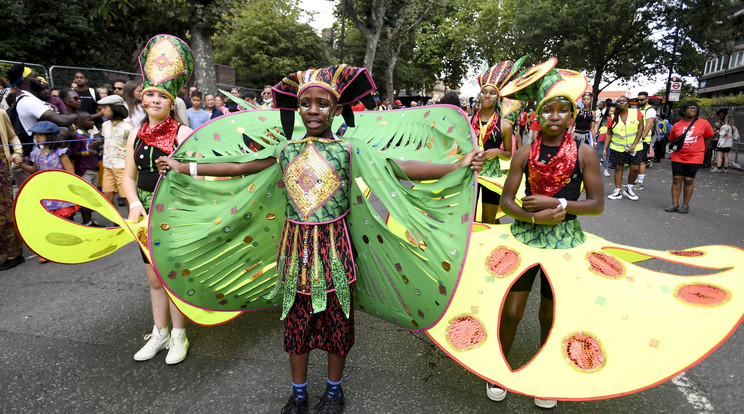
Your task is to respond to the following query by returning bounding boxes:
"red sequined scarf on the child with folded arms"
[527,132,578,197]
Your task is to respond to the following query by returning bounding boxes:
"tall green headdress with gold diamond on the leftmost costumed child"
[139,34,194,102]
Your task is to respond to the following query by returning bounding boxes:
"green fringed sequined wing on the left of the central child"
[149,110,300,311]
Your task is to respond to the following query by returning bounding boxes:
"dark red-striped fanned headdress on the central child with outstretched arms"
[271,64,375,139]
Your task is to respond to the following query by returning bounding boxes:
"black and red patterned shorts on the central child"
[284,285,354,356]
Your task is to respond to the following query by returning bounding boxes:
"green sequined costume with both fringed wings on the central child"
[150,106,475,330]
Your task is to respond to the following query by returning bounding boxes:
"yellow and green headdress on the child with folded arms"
[500,58,588,114]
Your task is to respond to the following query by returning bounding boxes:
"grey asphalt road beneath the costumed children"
[0,161,744,413]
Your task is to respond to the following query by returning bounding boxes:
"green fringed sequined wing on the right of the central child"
[344,106,476,330]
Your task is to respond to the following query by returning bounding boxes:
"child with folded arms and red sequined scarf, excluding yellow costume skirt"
[487,63,604,408]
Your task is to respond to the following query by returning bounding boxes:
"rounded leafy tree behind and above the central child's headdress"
[214,0,330,88]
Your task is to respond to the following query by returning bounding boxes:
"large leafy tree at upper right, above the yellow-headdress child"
[477,0,661,106]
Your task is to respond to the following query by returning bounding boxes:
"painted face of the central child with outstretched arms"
[298,87,342,138]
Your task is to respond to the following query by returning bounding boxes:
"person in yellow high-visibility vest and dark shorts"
[602,96,645,200]
